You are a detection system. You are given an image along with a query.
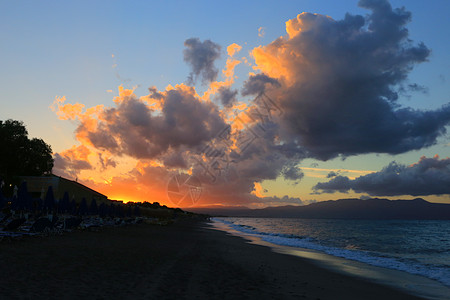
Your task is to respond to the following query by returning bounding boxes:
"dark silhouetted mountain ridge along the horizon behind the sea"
[185,198,450,220]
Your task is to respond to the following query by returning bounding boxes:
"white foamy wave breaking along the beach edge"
[213,218,450,287]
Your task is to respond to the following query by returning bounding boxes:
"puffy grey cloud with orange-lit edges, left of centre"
[77,88,226,159]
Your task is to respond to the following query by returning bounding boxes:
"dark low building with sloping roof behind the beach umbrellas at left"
[20,175,108,203]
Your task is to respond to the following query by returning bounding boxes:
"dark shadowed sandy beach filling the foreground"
[0,220,421,299]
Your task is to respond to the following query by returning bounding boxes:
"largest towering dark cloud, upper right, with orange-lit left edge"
[251,0,450,160]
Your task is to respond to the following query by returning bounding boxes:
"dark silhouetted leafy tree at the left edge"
[0,120,53,180]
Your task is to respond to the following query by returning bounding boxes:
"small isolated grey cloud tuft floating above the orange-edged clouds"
[183,38,221,84]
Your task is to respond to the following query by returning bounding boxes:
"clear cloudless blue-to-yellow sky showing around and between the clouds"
[0,0,450,202]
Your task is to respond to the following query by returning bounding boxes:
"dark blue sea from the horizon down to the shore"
[214,218,450,287]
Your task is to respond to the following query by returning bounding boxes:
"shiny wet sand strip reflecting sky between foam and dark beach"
[213,221,450,300]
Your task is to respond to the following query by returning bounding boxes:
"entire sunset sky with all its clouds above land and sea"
[0,0,450,208]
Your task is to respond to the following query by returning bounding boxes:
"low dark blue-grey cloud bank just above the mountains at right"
[314,155,450,196]
